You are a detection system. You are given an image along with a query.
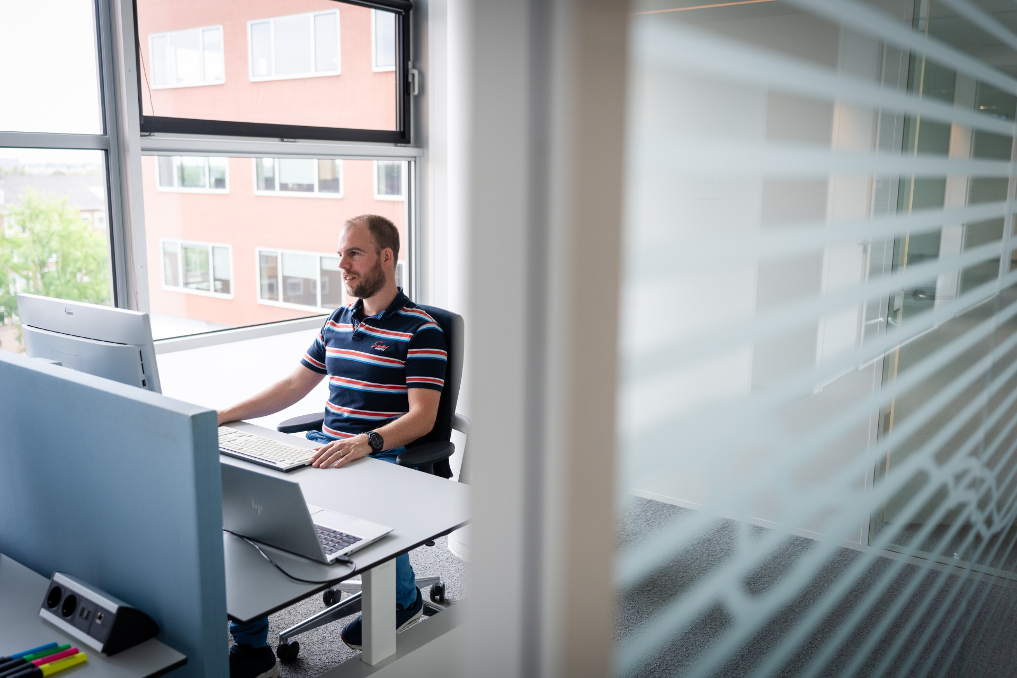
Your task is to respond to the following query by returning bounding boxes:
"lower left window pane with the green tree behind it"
[0,149,111,353]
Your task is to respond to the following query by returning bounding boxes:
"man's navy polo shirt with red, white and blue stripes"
[300,289,447,438]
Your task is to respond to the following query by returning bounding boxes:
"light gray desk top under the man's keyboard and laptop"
[222,422,469,622]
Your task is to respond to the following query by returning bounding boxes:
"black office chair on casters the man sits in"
[266,305,470,663]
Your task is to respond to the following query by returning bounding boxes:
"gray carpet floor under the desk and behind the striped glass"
[230,499,1017,678]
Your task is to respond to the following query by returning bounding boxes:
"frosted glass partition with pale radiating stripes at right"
[615,0,1017,676]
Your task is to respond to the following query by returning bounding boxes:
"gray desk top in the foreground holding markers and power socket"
[0,555,187,678]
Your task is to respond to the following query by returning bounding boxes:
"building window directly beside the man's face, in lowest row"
[257,248,344,310]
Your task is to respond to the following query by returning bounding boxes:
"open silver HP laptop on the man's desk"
[220,464,392,564]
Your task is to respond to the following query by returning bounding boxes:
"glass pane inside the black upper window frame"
[137,0,402,132]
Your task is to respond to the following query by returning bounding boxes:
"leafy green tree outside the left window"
[0,189,110,325]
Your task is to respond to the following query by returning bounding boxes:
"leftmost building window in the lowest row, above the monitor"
[162,240,233,299]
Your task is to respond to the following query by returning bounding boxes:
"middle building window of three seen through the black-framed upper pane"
[247,9,341,80]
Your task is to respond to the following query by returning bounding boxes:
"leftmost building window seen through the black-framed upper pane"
[148,25,226,89]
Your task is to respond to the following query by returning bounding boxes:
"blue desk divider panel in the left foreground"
[0,352,229,676]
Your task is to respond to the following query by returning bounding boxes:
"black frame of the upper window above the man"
[132,0,413,144]
